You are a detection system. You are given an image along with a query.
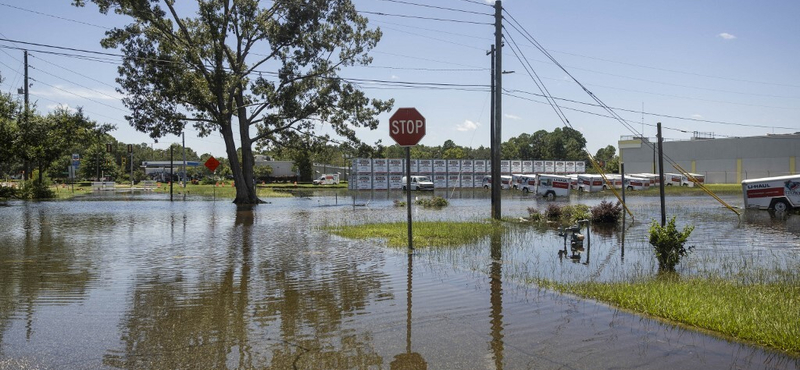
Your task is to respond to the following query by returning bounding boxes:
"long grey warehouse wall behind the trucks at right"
[619,133,800,183]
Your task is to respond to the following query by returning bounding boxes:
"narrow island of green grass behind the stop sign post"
[326,221,503,248]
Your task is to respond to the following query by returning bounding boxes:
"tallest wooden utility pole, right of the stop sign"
[491,0,503,220]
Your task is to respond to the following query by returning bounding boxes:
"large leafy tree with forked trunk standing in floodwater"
[74,0,391,204]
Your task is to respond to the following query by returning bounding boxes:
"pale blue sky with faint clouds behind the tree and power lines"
[0,0,800,157]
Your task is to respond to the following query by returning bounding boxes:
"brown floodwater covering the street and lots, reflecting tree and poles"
[0,189,800,370]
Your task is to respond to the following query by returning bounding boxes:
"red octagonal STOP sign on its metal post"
[389,108,425,251]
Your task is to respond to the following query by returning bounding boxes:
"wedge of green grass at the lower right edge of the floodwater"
[536,277,800,355]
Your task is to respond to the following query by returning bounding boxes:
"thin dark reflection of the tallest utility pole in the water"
[489,230,503,370]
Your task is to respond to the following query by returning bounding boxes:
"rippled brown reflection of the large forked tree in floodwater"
[103,204,390,369]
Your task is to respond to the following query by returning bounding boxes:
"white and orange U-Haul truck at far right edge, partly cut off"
[742,175,800,212]
